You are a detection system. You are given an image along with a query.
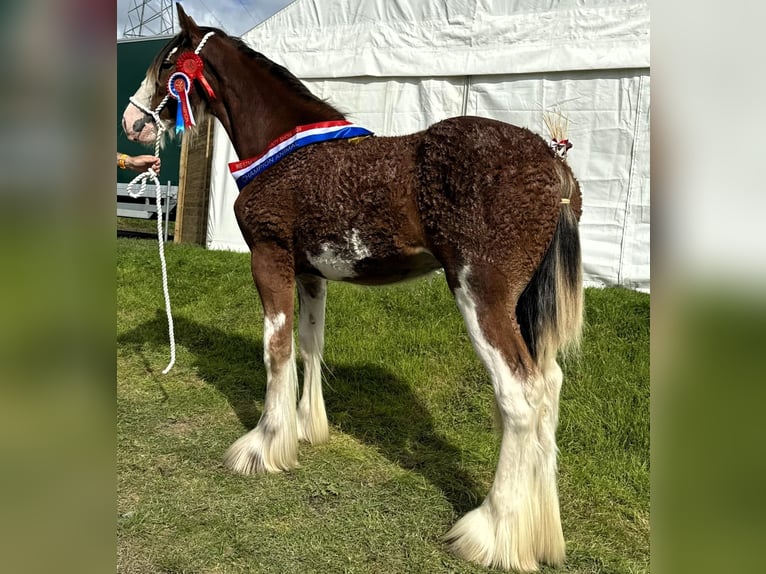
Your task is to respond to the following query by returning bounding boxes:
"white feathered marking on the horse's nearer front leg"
[224,313,298,474]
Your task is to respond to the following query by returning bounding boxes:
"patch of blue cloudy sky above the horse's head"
[117,0,293,39]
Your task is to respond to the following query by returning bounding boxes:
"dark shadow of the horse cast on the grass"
[117,311,481,514]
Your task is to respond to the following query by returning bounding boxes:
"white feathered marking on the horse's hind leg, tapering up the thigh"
[446,268,563,572]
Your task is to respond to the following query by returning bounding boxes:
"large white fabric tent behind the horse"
[207,0,649,291]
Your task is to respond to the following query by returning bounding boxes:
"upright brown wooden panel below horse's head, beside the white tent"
[173,118,213,246]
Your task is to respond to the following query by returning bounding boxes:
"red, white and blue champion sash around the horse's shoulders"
[229,120,372,190]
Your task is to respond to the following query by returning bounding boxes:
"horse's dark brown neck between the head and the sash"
[211,45,343,159]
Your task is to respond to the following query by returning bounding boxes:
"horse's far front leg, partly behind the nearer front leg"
[298,275,330,444]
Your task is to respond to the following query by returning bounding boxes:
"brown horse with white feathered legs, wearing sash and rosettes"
[122,4,583,572]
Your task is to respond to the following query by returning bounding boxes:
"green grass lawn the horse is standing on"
[117,239,649,574]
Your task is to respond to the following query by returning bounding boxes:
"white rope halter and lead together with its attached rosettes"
[127,31,215,375]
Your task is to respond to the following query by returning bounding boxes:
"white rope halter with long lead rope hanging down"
[127,32,215,375]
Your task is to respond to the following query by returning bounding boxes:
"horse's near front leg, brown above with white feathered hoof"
[225,249,298,474]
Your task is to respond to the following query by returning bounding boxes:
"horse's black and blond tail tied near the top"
[516,159,583,365]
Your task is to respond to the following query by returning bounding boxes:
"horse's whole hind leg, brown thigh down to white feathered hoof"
[446,266,564,572]
